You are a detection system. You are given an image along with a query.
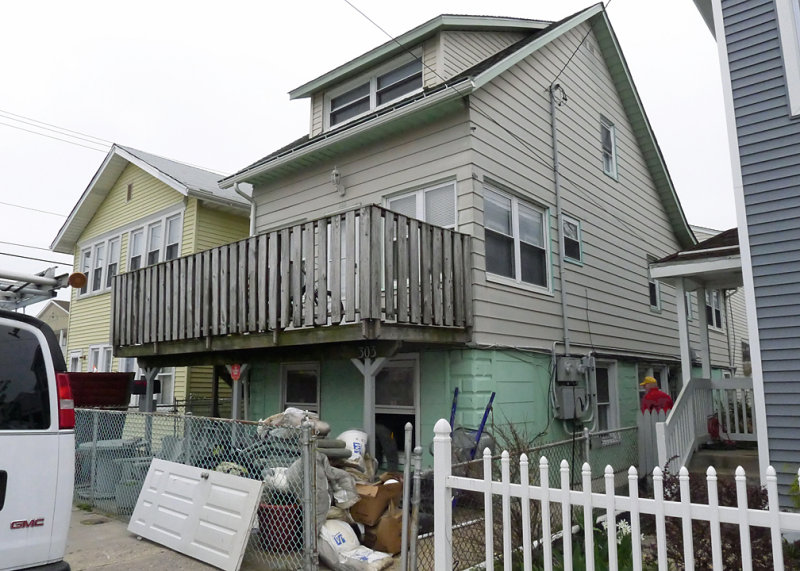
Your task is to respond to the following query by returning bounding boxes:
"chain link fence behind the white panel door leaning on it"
[74,409,316,569]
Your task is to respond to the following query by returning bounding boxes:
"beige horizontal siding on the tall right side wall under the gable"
[471,24,692,362]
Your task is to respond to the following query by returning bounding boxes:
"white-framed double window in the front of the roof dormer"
[326,54,422,128]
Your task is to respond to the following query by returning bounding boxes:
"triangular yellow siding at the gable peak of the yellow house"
[78,164,183,244]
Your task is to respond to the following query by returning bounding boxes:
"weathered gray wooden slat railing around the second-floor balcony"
[112,206,472,346]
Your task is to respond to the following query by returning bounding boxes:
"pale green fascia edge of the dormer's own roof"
[289,15,550,99]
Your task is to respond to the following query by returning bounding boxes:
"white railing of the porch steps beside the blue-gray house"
[656,377,756,466]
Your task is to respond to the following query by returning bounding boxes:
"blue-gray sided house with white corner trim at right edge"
[695,0,800,505]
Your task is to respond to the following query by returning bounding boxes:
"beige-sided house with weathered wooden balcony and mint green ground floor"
[113,4,744,468]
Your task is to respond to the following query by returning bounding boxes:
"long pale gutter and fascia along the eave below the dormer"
[219,84,474,188]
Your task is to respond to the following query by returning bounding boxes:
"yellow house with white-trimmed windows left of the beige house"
[50,145,250,405]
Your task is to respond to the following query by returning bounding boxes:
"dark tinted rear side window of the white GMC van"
[0,325,50,430]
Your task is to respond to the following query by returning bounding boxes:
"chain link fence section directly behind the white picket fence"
[416,427,639,571]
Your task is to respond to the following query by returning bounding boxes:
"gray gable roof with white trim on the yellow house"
[50,144,250,254]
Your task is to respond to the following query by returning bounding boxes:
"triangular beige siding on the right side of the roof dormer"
[438,31,527,79]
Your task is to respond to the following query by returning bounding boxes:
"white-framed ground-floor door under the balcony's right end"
[375,355,419,471]
